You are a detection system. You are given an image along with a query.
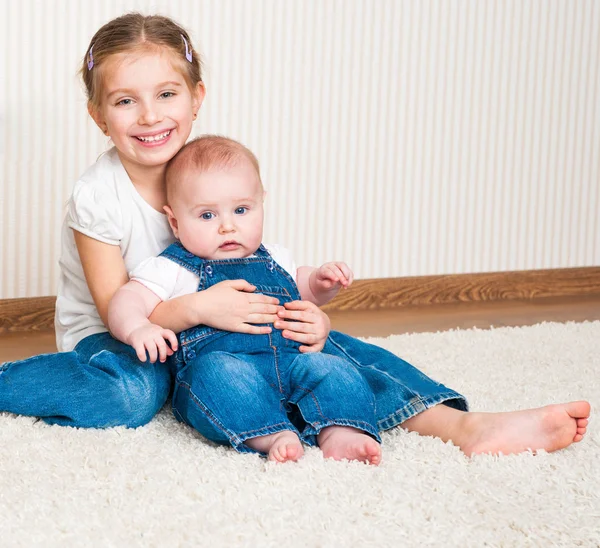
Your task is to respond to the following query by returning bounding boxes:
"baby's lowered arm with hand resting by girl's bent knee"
[108,281,177,363]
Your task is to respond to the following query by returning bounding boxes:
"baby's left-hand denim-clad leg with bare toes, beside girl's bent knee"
[173,351,303,462]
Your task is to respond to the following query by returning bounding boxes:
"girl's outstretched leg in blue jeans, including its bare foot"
[323,331,590,455]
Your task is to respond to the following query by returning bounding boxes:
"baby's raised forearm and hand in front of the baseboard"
[296,262,354,306]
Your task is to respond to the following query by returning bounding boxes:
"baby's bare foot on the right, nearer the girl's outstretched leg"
[317,426,381,466]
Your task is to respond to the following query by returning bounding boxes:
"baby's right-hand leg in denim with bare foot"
[290,353,381,465]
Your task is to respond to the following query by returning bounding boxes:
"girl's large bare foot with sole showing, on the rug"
[458,401,590,456]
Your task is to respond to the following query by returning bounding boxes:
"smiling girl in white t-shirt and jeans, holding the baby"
[0,14,590,454]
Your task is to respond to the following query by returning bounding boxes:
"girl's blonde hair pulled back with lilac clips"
[79,13,202,107]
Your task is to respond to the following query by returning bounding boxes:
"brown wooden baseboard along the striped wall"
[0,267,600,332]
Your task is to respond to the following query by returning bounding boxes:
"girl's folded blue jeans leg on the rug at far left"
[0,333,171,428]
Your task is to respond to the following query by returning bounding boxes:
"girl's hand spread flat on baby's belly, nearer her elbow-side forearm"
[197,280,282,335]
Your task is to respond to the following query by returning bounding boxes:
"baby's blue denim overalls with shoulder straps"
[161,242,380,452]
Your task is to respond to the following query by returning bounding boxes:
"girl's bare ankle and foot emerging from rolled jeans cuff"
[402,401,590,456]
